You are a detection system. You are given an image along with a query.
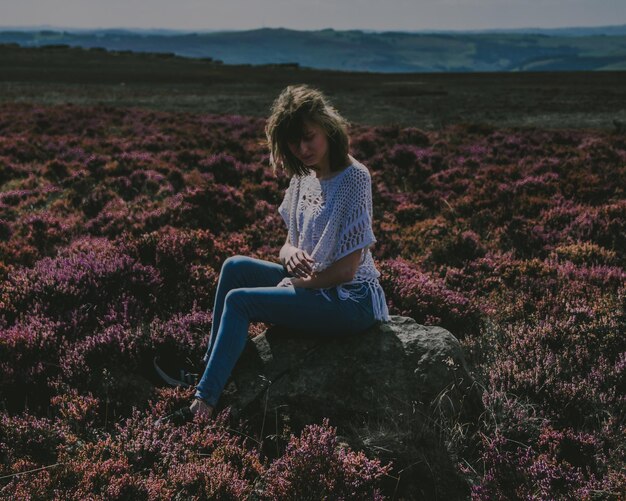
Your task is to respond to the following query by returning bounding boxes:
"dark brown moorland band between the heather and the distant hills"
[0,45,626,130]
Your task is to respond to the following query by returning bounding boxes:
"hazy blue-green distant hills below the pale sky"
[0,26,626,73]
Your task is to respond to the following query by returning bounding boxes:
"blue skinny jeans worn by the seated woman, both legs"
[195,256,376,407]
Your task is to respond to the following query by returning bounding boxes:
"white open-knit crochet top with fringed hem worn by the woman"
[278,156,389,322]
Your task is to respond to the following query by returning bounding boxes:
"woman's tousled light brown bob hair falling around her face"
[265,85,349,175]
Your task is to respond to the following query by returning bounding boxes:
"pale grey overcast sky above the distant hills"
[0,0,626,31]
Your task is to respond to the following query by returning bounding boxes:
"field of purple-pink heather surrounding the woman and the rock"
[0,103,626,500]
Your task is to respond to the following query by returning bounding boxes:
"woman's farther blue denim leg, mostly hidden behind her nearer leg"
[203,256,287,362]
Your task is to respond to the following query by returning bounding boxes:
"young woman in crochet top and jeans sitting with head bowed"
[158,85,389,418]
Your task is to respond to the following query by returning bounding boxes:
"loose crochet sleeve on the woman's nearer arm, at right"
[330,169,376,262]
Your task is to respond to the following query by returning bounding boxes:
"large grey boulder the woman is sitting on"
[222,316,483,499]
